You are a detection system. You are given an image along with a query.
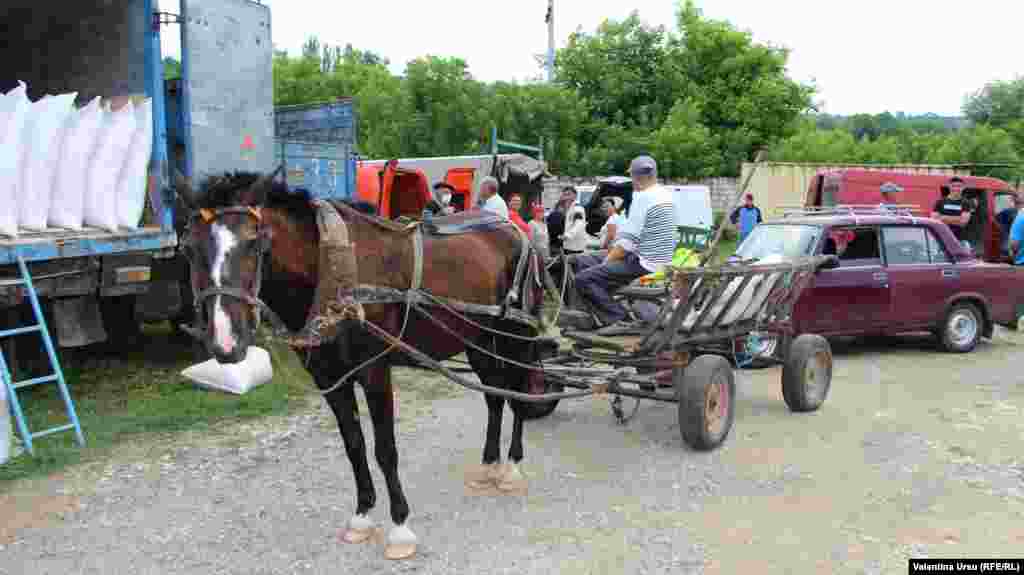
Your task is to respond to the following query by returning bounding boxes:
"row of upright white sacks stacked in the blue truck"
[0,82,153,237]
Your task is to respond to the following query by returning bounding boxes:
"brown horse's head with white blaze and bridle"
[176,169,280,363]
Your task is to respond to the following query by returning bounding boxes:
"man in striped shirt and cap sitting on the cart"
[575,156,677,329]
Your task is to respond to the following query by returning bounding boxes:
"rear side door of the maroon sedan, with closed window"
[882,225,959,331]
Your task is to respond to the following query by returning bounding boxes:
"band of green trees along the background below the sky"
[235,0,1024,179]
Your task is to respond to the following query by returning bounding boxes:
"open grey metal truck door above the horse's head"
[181,0,274,180]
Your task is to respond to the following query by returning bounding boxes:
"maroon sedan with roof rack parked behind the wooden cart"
[730,209,1024,357]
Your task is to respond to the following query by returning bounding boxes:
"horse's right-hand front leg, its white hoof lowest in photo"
[364,365,417,559]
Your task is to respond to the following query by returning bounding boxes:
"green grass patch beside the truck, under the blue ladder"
[0,325,313,483]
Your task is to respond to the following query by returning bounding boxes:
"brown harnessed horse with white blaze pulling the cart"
[178,167,551,559]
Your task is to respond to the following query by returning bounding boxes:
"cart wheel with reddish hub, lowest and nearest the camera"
[674,354,736,451]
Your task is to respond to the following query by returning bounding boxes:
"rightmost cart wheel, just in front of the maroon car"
[782,334,831,411]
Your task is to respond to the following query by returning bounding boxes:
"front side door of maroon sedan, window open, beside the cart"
[794,226,890,335]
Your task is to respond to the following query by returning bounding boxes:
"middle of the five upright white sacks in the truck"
[47,96,103,229]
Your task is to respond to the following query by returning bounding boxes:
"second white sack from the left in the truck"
[17,92,78,231]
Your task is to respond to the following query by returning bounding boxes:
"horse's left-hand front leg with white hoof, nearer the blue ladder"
[318,382,377,543]
